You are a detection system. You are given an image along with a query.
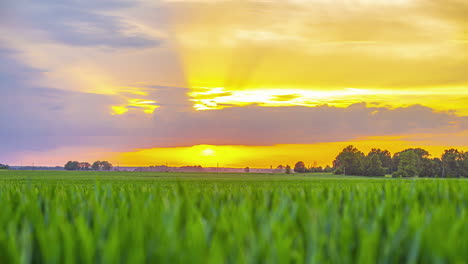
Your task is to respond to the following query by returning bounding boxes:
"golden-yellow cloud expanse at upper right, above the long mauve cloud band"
[169,0,468,114]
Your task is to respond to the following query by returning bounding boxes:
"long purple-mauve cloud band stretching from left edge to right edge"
[0,48,468,155]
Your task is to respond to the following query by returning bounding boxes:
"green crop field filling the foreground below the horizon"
[0,171,468,263]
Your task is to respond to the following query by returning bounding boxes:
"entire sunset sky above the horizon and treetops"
[0,0,468,167]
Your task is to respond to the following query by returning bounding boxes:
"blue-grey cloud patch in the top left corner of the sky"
[0,0,163,48]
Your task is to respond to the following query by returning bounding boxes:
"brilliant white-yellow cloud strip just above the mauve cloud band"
[189,88,468,115]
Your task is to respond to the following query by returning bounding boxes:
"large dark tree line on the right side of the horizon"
[333,145,468,178]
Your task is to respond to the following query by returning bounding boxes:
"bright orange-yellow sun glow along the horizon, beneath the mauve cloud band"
[111,131,468,168]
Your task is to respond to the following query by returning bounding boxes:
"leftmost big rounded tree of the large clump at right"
[333,145,365,175]
